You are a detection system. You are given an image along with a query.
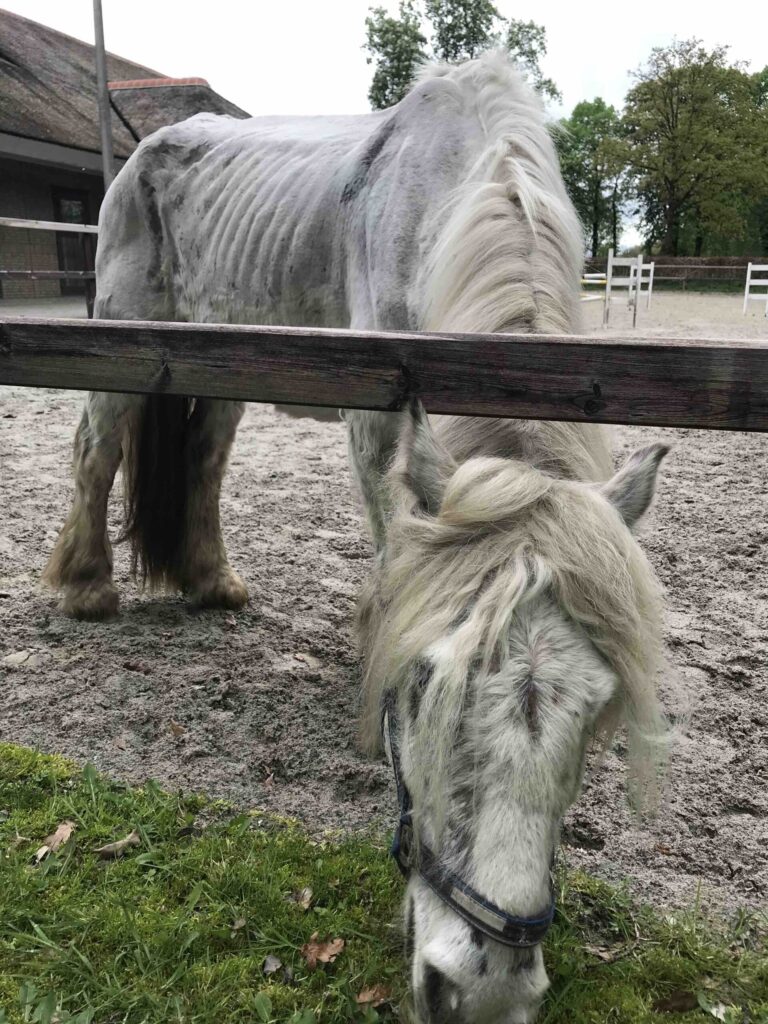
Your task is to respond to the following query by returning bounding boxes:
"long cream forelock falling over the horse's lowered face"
[362,458,667,806]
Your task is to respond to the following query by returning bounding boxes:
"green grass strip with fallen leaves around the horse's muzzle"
[0,744,768,1024]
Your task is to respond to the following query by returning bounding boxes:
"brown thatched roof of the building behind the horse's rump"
[0,10,248,158]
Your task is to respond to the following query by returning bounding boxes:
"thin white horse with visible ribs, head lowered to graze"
[47,54,665,1024]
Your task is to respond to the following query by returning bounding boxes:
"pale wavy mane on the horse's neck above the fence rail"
[420,50,583,333]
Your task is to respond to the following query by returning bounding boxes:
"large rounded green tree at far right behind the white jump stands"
[624,39,768,255]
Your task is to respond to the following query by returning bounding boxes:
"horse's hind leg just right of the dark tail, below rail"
[179,398,248,608]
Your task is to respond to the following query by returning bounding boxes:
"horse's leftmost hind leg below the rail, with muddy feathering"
[43,392,142,618]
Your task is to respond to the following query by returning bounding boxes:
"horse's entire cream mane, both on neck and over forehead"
[358,58,668,817]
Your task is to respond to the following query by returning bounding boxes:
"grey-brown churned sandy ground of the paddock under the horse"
[0,294,768,908]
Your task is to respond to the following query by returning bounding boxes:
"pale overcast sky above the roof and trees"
[6,0,768,114]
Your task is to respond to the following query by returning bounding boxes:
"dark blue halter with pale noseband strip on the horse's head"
[382,690,555,948]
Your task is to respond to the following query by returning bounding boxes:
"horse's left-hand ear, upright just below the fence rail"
[397,398,456,515]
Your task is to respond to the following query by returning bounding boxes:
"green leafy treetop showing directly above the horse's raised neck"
[365,0,560,110]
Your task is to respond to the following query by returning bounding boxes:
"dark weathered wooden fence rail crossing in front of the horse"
[0,318,768,431]
